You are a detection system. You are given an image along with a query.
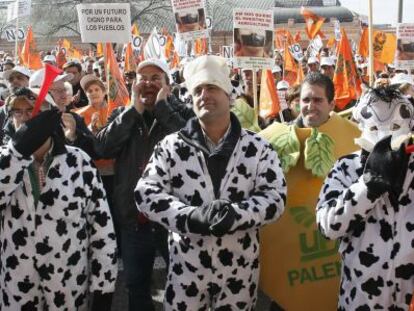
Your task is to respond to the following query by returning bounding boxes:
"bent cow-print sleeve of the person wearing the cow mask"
[316,154,379,239]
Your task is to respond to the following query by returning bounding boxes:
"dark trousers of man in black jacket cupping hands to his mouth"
[121,223,168,311]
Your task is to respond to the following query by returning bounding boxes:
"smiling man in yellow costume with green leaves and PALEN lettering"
[259,72,360,311]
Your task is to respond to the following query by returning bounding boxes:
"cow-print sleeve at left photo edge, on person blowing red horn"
[0,141,32,212]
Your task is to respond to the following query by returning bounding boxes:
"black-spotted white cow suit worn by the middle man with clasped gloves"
[135,130,286,311]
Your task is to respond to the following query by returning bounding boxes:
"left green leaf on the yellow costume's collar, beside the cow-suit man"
[270,125,300,173]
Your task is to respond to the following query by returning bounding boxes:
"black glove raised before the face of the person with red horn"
[13,110,61,157]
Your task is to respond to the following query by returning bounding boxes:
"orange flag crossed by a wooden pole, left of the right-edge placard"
[358,27,397,64]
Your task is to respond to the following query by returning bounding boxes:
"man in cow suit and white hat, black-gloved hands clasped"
[135,55,286,311]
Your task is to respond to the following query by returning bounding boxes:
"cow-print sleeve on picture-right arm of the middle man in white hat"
[232,145,287,230]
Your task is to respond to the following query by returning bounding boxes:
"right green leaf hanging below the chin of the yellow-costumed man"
[304,128,336,178]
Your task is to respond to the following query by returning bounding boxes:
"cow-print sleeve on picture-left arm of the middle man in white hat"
[135,137,196,235]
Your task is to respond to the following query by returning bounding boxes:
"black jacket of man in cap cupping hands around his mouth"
[97,97,194,226]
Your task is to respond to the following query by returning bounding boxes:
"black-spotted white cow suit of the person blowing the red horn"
[0,142,117,311]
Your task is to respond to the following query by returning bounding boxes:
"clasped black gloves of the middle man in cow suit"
[187,200,234,235]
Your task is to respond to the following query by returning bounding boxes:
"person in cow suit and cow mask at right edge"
[317,87,414,311]
